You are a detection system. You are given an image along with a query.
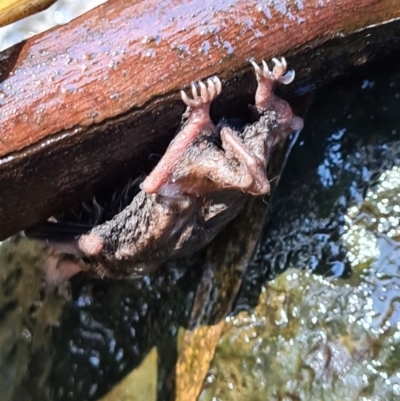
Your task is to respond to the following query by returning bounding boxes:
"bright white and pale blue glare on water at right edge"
[343,166,400,332]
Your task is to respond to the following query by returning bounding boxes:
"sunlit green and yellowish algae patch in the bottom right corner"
[200,269,400,401]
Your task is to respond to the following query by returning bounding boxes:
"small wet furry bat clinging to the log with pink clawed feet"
[26,58,303,287]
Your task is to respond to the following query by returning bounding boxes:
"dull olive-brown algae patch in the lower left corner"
[0,236,67,401]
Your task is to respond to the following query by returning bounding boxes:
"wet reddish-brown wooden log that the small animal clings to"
[0,0,400,239]
